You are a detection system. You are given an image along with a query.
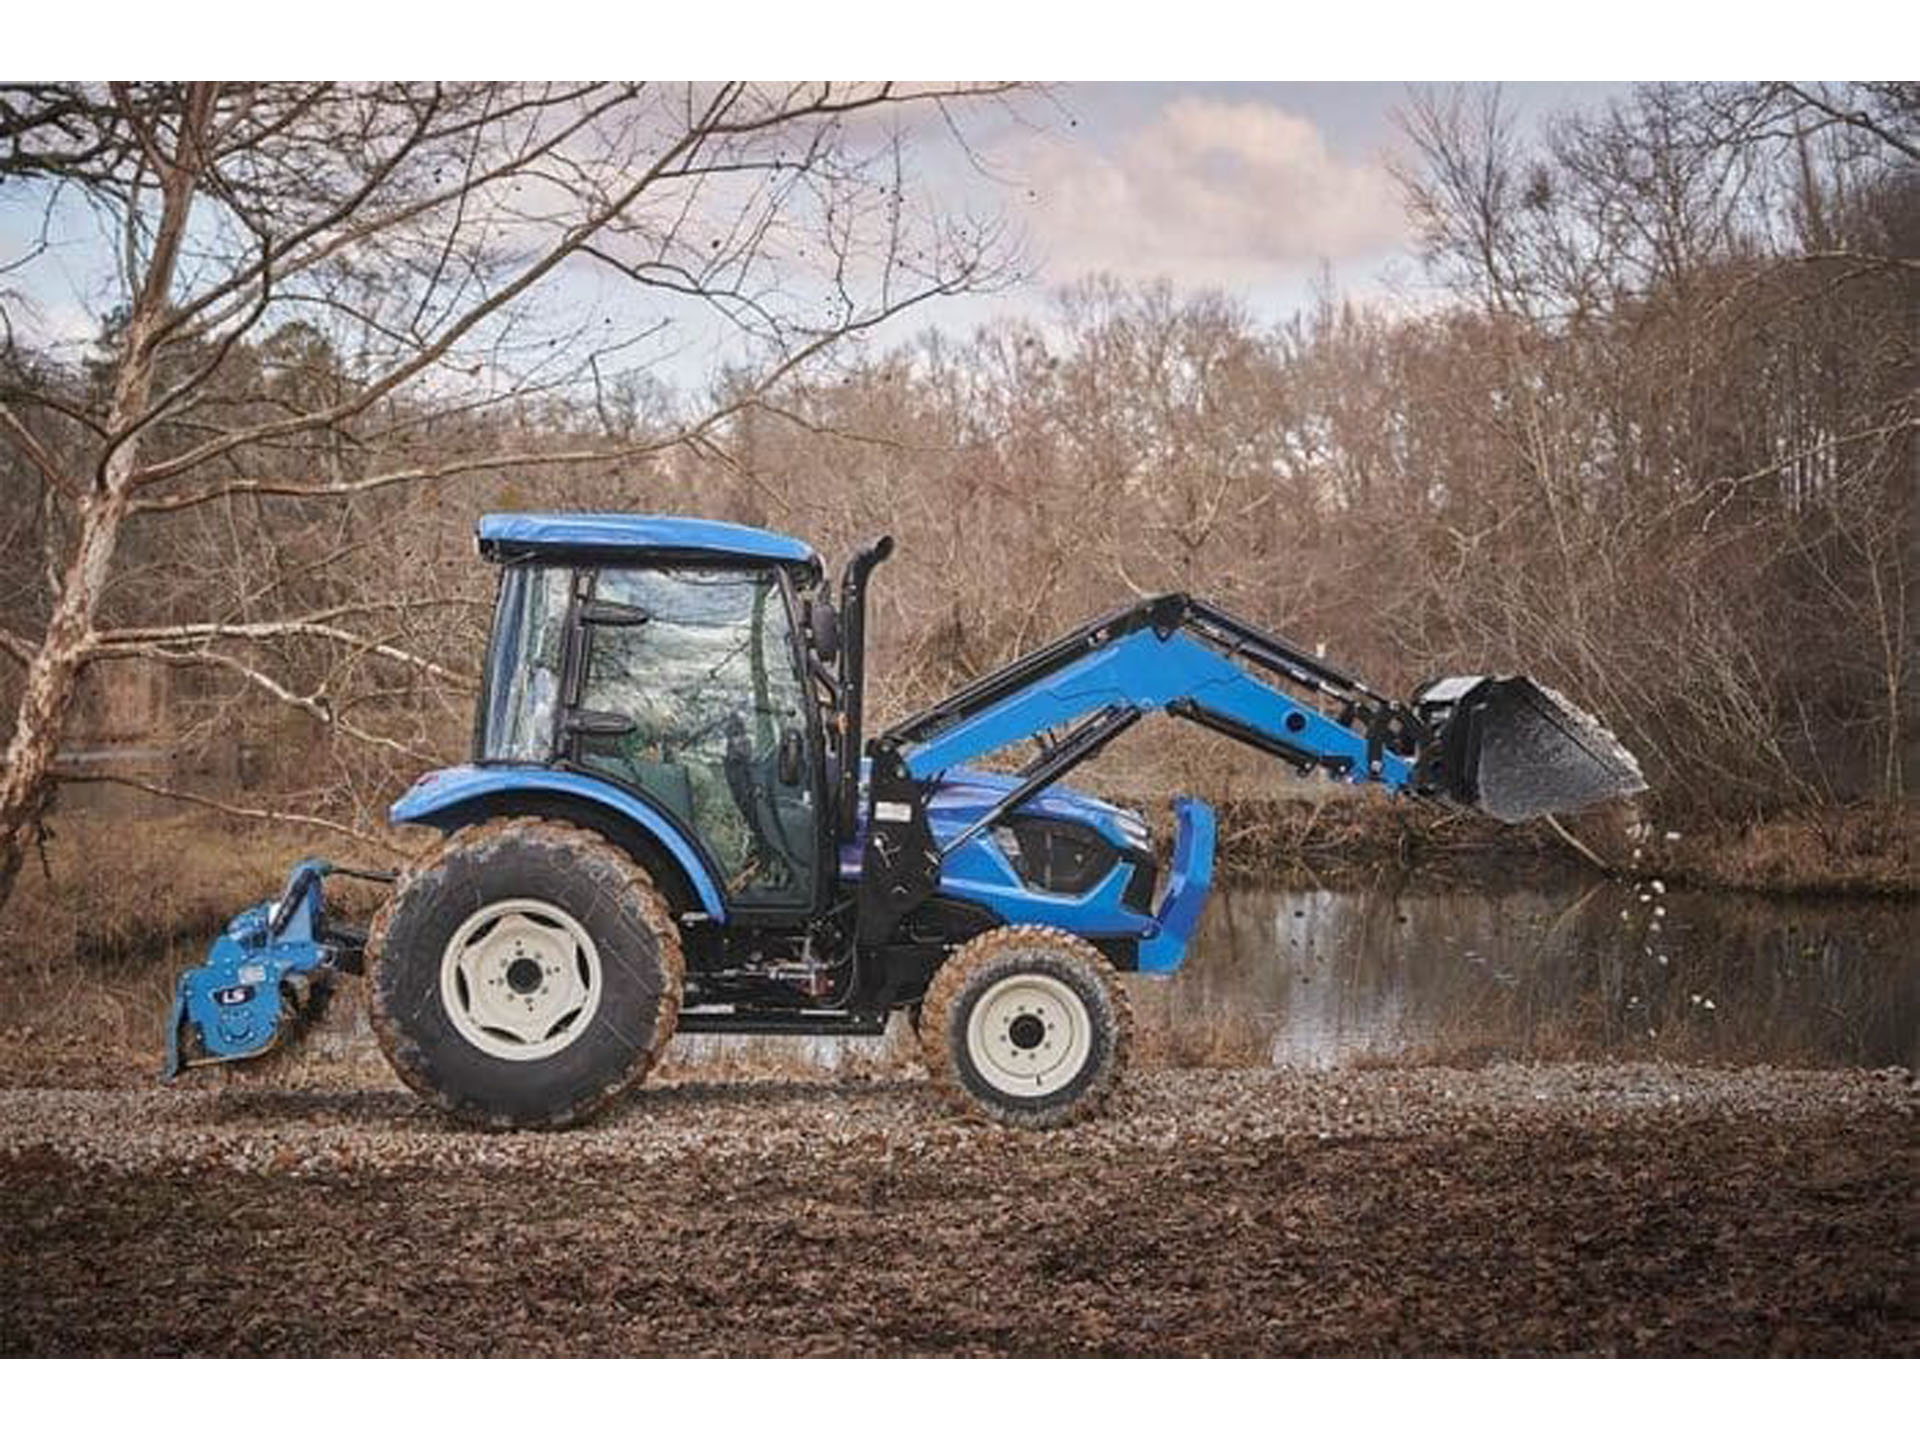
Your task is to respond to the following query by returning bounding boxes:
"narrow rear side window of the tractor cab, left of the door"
[478,566,574,764]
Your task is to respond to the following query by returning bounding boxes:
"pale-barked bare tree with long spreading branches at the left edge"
[0,83,1012,906]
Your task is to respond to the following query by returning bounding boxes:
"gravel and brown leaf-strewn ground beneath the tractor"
[0,1066,1920,1356]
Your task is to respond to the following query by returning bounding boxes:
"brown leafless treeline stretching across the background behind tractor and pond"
[0,86,1920,844]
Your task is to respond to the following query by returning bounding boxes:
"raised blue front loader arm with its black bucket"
[860,595,1642,941]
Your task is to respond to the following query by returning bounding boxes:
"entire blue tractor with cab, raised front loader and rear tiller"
[167,515,1642,1129]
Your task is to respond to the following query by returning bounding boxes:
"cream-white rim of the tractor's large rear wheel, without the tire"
[440,900,601,1060]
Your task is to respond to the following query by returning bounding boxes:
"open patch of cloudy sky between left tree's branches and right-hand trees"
[918,83,1630,341]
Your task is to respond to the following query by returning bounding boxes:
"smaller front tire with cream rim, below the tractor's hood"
[920,925,1133,1129]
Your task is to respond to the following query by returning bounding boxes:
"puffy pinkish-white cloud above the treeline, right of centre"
[1018,96,1407,286]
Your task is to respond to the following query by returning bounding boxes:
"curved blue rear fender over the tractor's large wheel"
[388,764,726,922]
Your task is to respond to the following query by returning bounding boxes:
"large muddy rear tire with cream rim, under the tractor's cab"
[367,818,685,1129]
